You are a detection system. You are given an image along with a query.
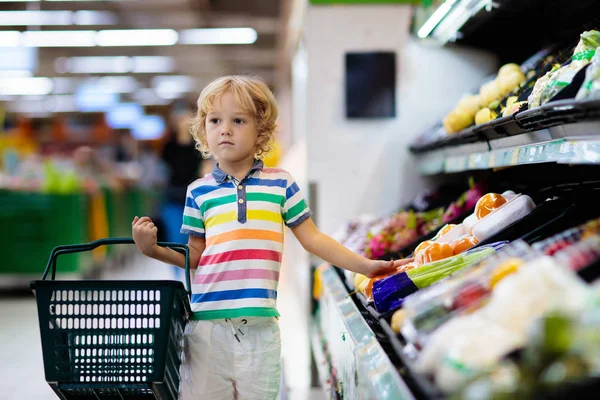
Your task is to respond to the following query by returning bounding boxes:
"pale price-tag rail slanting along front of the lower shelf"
[318,266,414,400]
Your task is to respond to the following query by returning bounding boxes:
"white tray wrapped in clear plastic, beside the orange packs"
[472,195,535,241]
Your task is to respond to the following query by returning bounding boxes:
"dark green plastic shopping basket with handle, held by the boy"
[31,238,190,400]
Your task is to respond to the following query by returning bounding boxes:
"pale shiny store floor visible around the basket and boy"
[0,256,325,400]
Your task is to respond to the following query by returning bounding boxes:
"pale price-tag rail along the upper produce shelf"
[418,137,600,175]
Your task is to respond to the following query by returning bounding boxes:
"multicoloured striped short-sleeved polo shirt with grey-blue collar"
[181,160,310,320]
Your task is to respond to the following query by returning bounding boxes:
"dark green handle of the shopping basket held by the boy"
[41,238,192,296]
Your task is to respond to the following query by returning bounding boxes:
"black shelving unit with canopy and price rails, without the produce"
[313,0,600,399]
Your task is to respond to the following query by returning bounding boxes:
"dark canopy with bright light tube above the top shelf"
[415,0,600,60]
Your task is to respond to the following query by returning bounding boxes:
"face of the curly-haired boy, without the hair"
[206,92,258,162]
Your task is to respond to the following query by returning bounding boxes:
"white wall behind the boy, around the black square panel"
[304,5,497,233]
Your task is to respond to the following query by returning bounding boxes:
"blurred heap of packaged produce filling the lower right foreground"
[374,219,600,399]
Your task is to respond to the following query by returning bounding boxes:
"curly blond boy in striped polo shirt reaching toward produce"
[132,76,410,400]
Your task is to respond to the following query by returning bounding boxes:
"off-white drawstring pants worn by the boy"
[179,317,281,400]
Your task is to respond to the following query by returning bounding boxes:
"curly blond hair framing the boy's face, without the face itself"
[190,75,279,159]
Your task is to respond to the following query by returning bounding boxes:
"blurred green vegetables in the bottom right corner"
[452,304,600,400]
